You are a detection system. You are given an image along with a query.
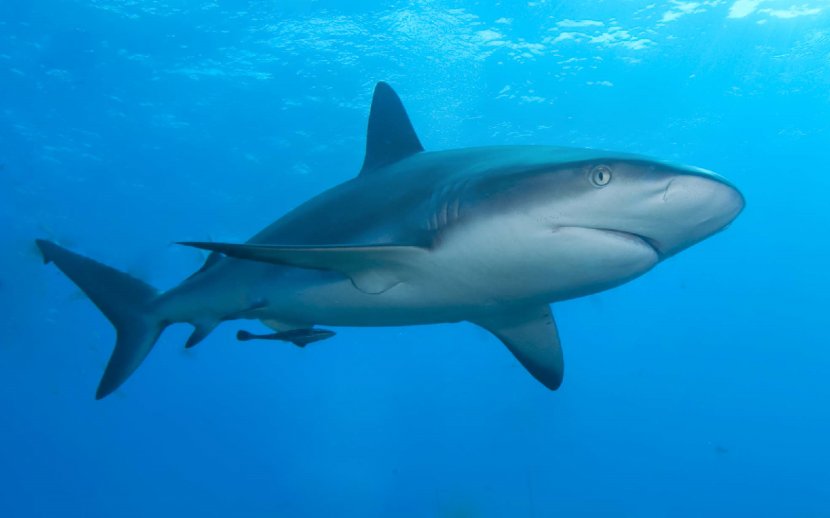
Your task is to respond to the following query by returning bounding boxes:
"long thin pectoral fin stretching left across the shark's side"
[179,242,428,294]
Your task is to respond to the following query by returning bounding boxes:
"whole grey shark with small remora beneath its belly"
[37,83,744,399]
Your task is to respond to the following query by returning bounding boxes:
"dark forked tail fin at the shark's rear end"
[35,239,166,399]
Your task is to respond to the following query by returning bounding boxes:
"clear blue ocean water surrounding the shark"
[0,0,830,517]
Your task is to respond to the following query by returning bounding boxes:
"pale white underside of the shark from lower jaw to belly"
[267,218,658,326]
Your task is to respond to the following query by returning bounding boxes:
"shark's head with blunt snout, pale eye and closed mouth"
[462,148,744,299]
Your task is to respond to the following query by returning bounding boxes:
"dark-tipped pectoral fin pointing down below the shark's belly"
[474,306,565,390]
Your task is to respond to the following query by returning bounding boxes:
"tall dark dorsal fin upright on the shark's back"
[360,81,424,174]
